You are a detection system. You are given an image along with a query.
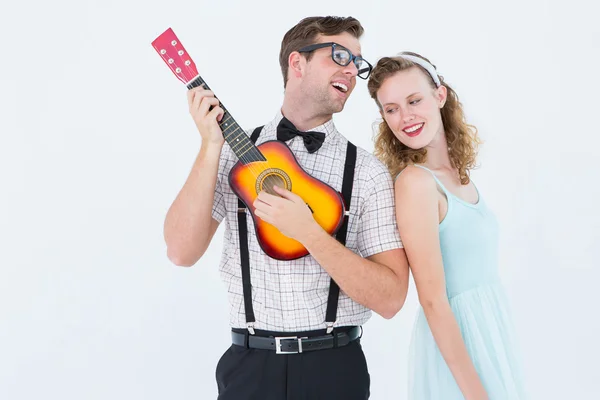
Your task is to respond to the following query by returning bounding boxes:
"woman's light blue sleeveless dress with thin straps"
[408,166,525,400]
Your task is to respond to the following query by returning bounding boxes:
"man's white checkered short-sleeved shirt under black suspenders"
[212,111,402,332]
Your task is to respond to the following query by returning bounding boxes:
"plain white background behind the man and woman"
[0,0,600,400]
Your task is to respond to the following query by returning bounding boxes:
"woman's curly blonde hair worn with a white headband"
[368,52,481,185]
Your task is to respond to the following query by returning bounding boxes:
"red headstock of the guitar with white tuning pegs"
[152,28,198,84]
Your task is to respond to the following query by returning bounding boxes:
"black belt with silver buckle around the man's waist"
[231,326,362,354]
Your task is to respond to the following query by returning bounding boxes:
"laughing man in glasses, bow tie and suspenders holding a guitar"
[165,17,408,400]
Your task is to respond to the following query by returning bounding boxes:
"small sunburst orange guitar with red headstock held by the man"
[152,28,345,260]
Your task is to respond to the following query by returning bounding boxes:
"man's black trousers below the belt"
[216,332,371,400]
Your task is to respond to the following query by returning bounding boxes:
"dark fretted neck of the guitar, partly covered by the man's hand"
[187,75,266,164]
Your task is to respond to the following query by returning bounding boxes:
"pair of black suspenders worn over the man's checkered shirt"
[237,126,356,335]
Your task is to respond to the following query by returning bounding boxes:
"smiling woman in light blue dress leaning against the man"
[368,52,524,400]
